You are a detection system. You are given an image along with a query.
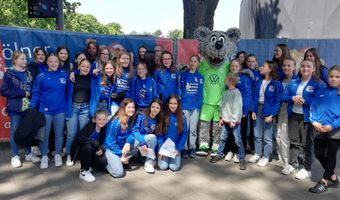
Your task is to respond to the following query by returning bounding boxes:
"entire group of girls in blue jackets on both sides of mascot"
[1,41,340,192]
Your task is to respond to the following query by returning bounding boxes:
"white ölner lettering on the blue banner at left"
[2,42,51,60]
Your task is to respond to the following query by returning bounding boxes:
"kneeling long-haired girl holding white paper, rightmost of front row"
[157,94,188,171]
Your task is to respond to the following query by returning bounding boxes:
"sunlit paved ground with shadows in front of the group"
[0,143,340,200]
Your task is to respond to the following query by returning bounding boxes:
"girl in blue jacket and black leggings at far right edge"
[309,65,340,193]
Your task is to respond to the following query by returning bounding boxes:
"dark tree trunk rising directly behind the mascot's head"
[183,0,219,39]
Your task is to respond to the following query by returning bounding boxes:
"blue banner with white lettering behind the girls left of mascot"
[0,26,157,67]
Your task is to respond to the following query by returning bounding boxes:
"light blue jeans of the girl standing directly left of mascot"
[183,109,200,150]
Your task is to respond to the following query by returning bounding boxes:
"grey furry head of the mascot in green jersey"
[194,26,241,66]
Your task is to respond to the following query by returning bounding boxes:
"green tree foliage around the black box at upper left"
[0,0,123,35]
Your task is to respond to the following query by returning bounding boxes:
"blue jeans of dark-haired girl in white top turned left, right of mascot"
[254,106,274,159]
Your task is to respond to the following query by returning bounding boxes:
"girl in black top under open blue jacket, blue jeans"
[65,59,95,166]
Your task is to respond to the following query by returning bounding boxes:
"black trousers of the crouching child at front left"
[78,143,107,170]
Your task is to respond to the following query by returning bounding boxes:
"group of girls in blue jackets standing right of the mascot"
[207,44,340,193]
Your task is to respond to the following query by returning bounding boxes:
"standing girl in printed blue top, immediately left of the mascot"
[180,55,203,158]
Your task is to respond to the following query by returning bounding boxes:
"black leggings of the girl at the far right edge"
[314,138,340,180]
